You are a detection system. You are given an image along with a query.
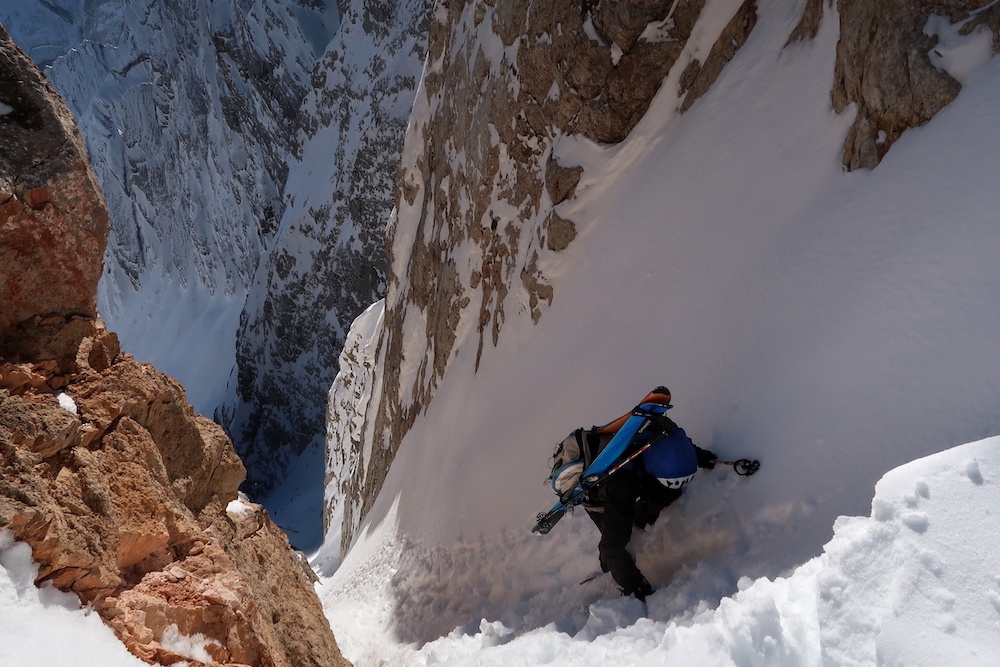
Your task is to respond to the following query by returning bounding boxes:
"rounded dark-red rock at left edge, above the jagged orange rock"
[0,28,108,334]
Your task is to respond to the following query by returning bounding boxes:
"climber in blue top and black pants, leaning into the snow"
[583,387,717,600]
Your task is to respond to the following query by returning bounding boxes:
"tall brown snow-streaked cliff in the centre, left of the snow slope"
[327,0,753,548]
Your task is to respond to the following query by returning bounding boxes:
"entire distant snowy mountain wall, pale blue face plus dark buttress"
[0,0,438,506]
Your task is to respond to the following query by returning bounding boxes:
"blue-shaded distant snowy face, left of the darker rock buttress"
[0,0,338,414]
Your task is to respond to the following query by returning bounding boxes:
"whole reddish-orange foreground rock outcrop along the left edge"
[0,24,346,666]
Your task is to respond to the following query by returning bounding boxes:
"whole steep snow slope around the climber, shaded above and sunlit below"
[314,0,1000,665]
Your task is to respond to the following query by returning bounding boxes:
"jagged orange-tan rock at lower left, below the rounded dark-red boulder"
[0,354,346,667]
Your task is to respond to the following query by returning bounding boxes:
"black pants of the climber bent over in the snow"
[587,470,681,597]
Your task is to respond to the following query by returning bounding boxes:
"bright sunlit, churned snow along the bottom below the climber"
[321,438,1000,667]
